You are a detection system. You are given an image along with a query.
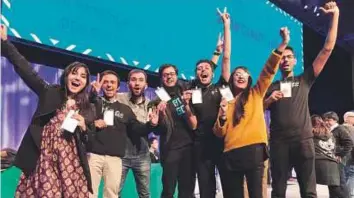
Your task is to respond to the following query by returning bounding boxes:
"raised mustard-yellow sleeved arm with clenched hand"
[255,27,290,97]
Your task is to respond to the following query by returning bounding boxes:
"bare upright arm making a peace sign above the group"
[217,7,231,82]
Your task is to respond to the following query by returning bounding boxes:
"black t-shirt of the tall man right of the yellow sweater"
[266,67,316,142]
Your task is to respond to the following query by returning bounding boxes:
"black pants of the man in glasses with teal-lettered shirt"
[161,146,195,198]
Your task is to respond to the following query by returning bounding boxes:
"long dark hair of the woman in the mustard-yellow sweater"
[229,66,252,126]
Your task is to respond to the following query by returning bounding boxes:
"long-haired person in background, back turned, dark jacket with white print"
[311,115,347,198]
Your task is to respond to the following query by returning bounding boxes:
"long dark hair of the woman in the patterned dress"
[60,62,90,111]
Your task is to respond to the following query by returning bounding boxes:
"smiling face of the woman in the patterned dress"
[66,66,88,95]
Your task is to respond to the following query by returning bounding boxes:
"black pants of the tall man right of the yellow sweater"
[270,139,317,198]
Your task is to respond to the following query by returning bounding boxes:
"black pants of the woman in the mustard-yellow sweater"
[219,162,264,198]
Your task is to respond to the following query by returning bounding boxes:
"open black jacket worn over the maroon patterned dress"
[1,41,95,192]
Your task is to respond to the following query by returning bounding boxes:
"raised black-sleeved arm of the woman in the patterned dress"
[0,25,48,95]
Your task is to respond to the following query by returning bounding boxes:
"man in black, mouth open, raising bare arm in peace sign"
[190,8,231,198]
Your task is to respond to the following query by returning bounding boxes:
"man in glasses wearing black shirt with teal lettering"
[151,64,196,198]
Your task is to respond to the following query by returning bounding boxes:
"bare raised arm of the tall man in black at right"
[312,1,339,77]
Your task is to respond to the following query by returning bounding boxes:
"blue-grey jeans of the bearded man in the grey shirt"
[119,153,151,198]
